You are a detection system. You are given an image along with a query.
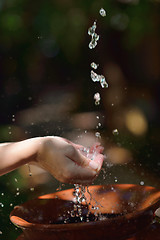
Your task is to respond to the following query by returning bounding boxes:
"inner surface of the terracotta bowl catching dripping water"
[10,184,160,225]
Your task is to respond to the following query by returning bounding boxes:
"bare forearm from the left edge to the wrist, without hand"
[0,137,43,175]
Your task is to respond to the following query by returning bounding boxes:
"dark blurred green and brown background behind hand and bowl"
[0,0,160,240]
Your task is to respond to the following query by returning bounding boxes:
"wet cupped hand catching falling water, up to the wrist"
[37,137,104,184]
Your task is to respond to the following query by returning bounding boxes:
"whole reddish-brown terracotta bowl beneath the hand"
[10,184,160,240]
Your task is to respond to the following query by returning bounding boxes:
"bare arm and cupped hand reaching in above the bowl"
[0,137,104,184]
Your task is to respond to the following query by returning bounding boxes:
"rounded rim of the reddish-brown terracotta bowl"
[9,184,160,231]
